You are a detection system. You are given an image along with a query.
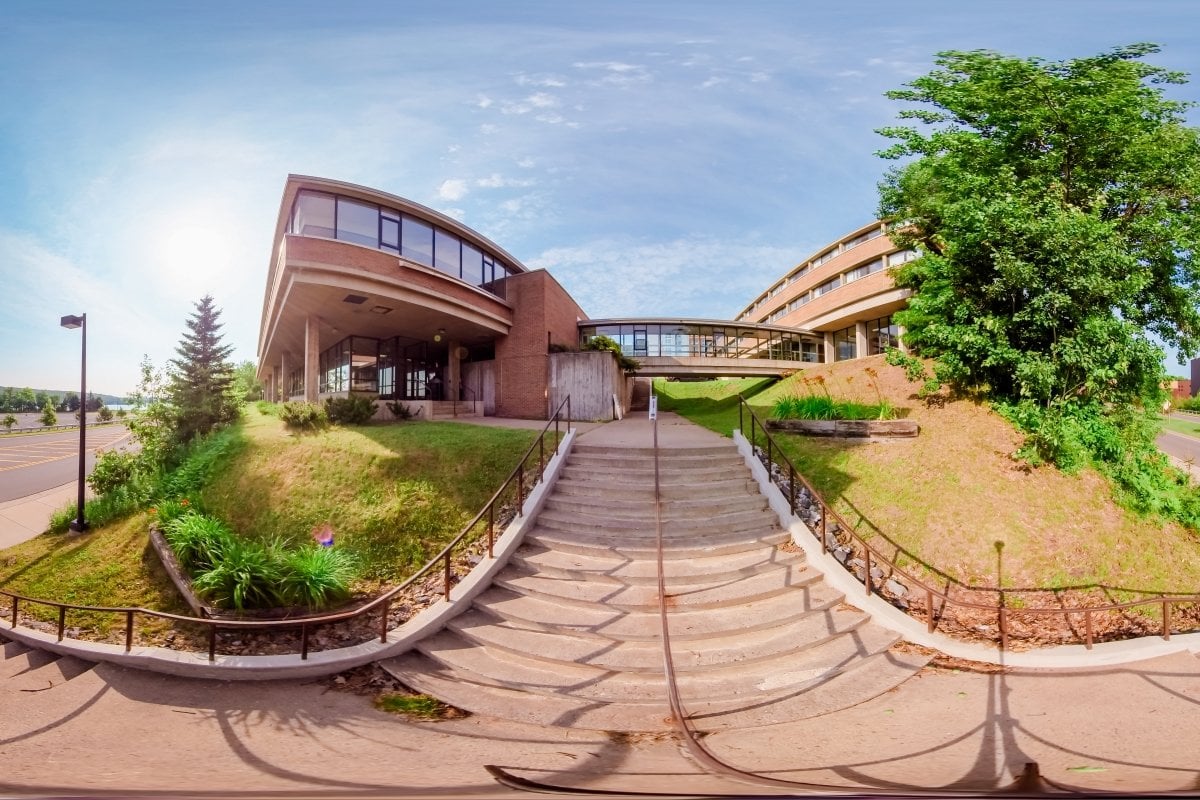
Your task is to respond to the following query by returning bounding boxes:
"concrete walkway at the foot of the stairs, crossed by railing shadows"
[0,642,1200,798]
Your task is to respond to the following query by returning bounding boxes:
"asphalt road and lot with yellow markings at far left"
[0,425,130,503]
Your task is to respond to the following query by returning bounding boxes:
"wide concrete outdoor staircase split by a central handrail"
[382,443,928,732]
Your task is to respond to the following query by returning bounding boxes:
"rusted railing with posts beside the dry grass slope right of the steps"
[738,397,1200,649]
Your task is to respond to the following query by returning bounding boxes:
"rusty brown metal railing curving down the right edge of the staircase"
[738,395,1200,650]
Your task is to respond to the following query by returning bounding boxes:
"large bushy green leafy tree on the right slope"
[880,44,1200,520]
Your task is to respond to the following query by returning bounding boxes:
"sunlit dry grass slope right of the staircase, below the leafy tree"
[656,356,1200,597]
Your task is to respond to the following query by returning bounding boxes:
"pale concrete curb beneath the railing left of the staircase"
[0,428,577,680]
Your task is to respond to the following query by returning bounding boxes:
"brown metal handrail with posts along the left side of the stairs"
[0,396,571,661]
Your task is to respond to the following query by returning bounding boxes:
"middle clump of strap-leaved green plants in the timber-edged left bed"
[192,536,284,610]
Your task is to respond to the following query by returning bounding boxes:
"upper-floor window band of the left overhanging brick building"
[289,190,516,297]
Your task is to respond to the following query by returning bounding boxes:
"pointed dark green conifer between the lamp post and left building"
[169,295,240,443]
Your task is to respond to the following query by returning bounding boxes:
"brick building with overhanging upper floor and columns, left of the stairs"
[258,175,583,417]
